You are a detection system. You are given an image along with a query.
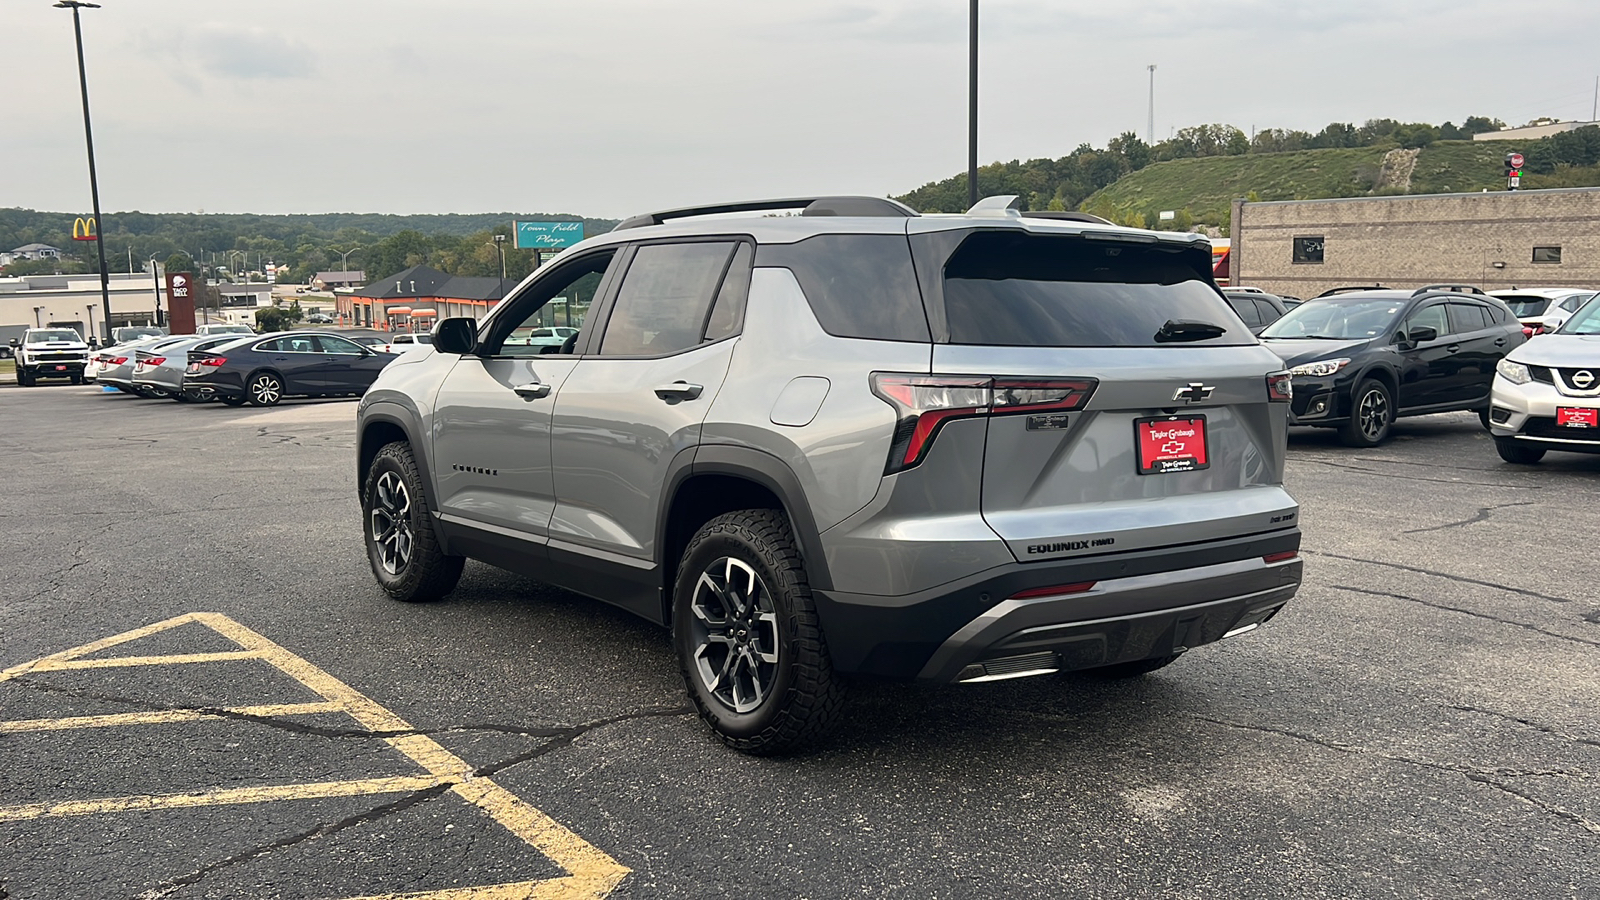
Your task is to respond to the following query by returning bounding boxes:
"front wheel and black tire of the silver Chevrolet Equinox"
[362,440,467,604]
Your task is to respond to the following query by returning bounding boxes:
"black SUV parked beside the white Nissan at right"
[1261,285,1525,447]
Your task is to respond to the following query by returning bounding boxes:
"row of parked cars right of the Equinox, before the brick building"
[1226,285,1600,464]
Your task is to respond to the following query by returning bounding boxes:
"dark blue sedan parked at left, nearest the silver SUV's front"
[184,331,398,407]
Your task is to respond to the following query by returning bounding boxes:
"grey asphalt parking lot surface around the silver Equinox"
[0,379,1600,900]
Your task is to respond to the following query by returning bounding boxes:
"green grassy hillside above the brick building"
[1082,141,1568,224]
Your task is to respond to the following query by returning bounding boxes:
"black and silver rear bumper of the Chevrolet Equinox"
[816,528,1302,682]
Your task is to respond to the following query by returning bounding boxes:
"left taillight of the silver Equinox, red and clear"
[872,372,1096,474]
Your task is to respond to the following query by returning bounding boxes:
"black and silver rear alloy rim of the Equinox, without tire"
[690,556,778,713]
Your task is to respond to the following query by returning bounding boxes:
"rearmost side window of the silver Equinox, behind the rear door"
[755,234,931,341]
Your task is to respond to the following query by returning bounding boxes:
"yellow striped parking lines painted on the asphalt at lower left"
[0,612,629,900]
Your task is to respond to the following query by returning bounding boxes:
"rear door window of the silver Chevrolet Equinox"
[600,242,734,356]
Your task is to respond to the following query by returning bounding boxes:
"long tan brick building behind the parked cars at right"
[1230,187,1600,296]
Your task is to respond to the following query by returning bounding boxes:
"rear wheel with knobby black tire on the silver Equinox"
[672,509,845,756]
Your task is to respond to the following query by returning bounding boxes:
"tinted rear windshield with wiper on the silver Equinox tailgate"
[944,232,1254,348]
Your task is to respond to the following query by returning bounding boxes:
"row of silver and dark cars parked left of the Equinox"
[61,325,432,407]
